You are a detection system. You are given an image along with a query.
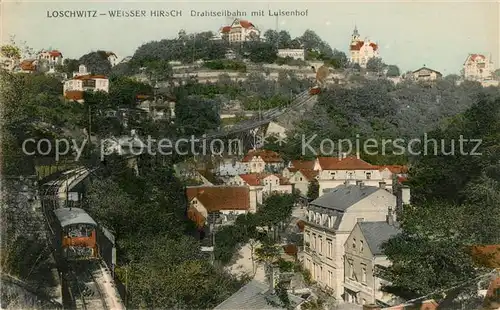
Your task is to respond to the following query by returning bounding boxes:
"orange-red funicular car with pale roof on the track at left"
[52,208,99,260]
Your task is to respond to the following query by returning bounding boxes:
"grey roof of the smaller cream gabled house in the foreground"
[357,222,401,255]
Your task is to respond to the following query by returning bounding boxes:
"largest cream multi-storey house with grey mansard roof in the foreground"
[301,184,396,299]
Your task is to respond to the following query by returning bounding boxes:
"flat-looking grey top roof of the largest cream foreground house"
[311,185,378,212]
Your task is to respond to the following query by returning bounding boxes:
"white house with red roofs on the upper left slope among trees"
[63,65,109,102]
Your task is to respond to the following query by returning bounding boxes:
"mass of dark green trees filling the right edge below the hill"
[382,95,500,298]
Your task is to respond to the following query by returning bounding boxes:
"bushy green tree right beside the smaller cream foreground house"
[379,203,480,298]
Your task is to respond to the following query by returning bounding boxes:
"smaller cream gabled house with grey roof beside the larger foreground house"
[343,210,400,305]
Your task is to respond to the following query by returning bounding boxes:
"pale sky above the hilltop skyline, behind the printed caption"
[1,0,500,74]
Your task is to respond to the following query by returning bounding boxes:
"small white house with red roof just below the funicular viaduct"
[241,150,284,173]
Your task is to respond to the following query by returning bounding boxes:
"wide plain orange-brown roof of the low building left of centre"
[186,186,250,212]
